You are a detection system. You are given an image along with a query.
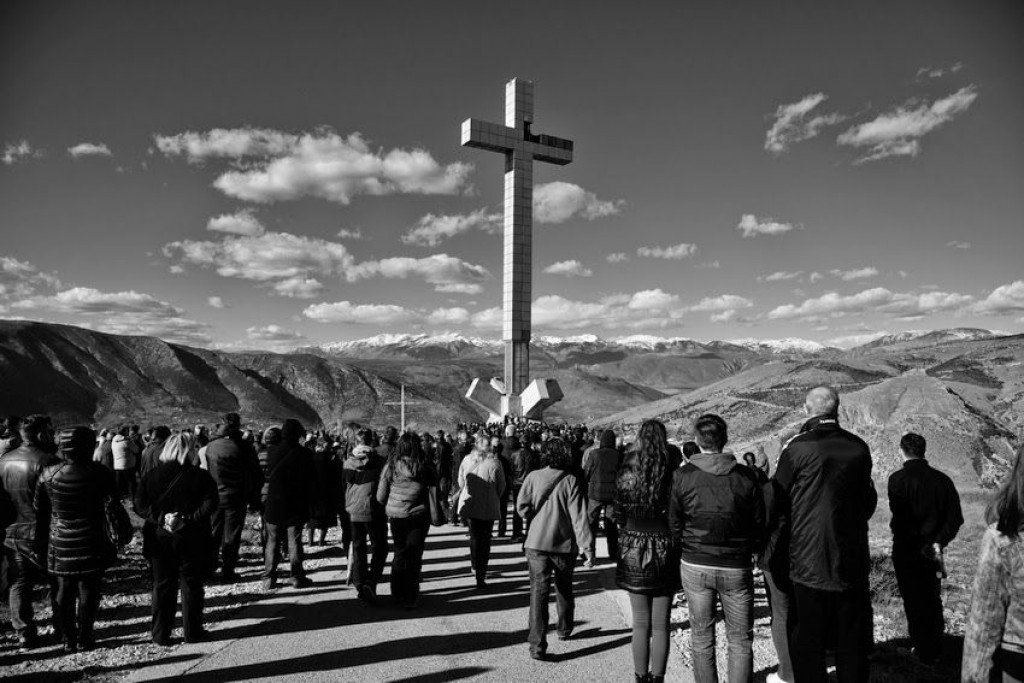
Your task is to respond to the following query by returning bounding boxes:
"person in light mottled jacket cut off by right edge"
[961,446,1024,683]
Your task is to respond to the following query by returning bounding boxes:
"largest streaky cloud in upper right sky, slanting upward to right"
[836,85,978,164]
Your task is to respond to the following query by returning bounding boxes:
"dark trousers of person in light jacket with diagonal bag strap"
[528,548,575,652]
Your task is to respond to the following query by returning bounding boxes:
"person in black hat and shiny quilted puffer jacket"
[34,427,127,652]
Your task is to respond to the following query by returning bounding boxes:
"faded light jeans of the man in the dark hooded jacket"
[680,561,754,683]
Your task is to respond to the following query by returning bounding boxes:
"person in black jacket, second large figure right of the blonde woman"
[260,420,316,590]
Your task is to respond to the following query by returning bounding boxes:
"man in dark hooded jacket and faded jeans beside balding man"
[669,415,765,681]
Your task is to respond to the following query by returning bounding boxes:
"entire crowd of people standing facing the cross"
[0,387,1024,683]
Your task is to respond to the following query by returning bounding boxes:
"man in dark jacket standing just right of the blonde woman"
[206,413,263,583]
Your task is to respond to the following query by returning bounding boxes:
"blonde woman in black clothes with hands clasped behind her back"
[135,433,218,646]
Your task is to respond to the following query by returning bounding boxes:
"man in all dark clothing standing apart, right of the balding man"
[889,433,964,665]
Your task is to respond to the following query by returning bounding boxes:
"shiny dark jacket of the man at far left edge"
[0,444,60,563]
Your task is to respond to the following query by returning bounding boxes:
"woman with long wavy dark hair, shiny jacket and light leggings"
[615,420,680,683]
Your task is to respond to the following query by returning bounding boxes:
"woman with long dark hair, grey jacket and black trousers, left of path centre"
[377,433,437,608]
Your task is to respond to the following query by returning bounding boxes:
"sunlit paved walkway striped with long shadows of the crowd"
[130,526,686,683]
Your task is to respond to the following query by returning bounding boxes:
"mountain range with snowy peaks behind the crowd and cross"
[0,321,1024,485]
